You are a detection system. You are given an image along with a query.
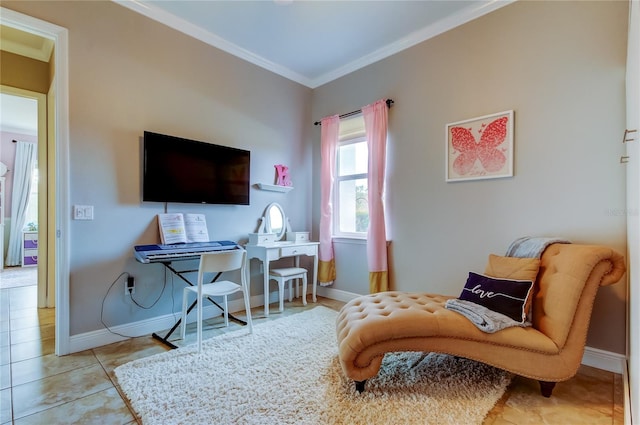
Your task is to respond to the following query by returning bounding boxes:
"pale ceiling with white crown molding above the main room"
[113,0,514,88]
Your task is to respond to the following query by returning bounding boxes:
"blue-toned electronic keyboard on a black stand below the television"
[134,241,240,264]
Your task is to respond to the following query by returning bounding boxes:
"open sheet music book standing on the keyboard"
[158,213,209,245]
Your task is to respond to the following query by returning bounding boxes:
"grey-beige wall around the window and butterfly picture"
[312,1,628,353]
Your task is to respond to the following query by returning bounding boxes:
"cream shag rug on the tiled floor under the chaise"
[115,306,511,425]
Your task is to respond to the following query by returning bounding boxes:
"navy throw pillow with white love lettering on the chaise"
[460,272,533,323]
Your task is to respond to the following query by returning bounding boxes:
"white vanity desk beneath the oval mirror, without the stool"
[245,241,320,316]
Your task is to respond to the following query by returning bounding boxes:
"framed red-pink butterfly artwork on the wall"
[445,111,513,182]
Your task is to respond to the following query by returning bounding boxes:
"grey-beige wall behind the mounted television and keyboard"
[3,1,311,336]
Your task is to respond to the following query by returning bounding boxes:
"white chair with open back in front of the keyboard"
[181,249,253,351]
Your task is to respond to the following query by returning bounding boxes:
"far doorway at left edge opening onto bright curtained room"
[0,86,47,308]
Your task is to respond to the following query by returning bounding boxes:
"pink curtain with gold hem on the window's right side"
[362,99,389,293]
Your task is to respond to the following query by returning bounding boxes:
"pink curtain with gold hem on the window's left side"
[318,115,340,286]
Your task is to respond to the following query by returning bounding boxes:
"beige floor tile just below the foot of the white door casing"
[11,350,99,386]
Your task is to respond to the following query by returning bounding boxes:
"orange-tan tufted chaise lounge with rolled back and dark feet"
[337,244,625,397]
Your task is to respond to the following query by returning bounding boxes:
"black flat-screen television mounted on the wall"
[142,131,251,205]
